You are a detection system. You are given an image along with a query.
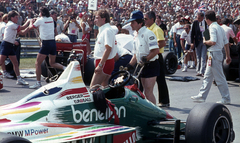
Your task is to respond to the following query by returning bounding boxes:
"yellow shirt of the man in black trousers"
[148,23,165,53]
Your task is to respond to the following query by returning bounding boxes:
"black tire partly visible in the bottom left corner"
[0,132,31,143]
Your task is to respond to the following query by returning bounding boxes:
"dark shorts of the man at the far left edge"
[0,41,16,56]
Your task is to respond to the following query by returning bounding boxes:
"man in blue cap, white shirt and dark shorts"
[127,10,160,105]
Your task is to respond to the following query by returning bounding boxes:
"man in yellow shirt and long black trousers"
[144,11,170,107]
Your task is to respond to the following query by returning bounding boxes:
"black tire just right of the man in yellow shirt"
[162,52,178,75]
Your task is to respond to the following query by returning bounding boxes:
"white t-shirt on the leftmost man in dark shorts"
[3,21,21,44]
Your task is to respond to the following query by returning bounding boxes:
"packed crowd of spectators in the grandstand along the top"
[0,0,240,36]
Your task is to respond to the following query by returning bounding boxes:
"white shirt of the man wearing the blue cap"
[133,26,159,63]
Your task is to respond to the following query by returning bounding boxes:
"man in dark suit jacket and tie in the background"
[191,12,207,77]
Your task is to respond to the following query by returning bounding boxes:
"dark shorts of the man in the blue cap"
[140,60,160,78]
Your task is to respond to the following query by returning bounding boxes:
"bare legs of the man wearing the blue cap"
[141,77,157,105]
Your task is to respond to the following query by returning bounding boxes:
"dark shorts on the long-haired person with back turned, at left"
[39,40,57,55]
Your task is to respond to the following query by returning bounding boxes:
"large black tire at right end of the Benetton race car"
[185,103,235,143]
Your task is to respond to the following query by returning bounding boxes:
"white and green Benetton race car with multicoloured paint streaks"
[0,61,235,143]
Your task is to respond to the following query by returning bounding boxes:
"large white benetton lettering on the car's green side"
[71,105,126,123]
